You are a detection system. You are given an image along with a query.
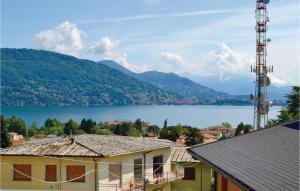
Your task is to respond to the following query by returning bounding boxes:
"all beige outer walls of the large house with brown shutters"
[0,148,171,191]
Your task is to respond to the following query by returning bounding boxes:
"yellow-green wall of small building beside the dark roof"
[171,163,211,191]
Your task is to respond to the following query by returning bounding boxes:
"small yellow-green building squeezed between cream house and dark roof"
[171,146,212,191]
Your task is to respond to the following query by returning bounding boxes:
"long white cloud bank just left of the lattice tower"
[160,42,254,77]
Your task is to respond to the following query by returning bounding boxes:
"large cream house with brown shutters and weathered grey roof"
[0,134,183,191]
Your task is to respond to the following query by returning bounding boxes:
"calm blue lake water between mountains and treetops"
[1,105,280,128]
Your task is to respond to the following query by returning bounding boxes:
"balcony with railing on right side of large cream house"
[147,170,183,185]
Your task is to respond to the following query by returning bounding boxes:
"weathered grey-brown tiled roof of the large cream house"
[0,134,175,157]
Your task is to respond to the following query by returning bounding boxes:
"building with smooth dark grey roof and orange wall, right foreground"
[188,121,300,191]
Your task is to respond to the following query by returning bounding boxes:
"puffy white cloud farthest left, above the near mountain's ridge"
[34,21,84,56]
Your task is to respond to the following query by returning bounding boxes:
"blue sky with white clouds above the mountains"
[1,0,300,86]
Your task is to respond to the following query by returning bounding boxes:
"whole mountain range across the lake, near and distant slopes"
[1,48,286,106]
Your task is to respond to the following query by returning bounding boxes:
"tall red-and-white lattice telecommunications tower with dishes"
[251,0,273,130]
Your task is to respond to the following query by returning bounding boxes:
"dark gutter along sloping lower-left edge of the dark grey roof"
[187,149,251,191]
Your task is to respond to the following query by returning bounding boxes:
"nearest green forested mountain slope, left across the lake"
[1,48,180,106]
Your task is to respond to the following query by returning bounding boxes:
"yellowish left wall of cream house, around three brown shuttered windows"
[0,156,95,191]
